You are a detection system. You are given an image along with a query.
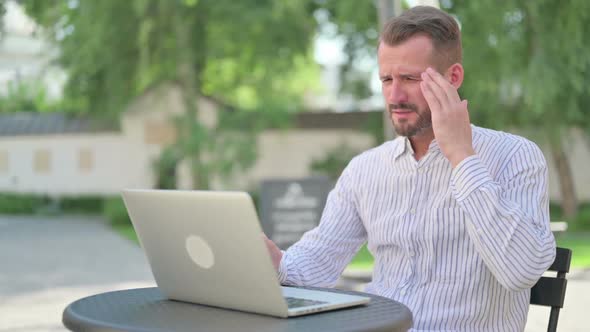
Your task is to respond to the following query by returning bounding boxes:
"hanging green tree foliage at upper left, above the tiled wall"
[22,0,317,115]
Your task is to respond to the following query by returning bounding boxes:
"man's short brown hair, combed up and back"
[379,6,463,69]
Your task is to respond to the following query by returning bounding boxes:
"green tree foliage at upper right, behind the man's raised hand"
[448,0,590,132]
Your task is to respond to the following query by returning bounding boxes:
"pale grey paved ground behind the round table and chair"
[0,216,590,332]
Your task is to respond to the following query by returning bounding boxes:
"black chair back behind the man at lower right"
[531,247,572,332]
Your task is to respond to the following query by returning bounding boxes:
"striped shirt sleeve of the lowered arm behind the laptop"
[278,162,367,287]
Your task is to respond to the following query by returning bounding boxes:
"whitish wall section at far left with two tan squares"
[0,133,149,196]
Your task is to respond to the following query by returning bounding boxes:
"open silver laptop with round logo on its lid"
[122,190,370,317]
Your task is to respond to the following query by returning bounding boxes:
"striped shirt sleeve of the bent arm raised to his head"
[451,141,555,291]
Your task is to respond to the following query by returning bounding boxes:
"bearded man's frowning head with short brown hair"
[378,6,463,137]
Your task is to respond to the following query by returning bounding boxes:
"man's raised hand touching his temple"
[420,68,475,167]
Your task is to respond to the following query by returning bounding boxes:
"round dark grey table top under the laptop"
[63,287,412,332]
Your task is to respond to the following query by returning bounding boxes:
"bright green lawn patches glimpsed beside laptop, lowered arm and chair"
[114,225,590,270]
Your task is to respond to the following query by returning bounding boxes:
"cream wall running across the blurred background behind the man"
[0,123,590,201]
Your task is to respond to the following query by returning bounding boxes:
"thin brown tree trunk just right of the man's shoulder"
[551,140,578,218]
